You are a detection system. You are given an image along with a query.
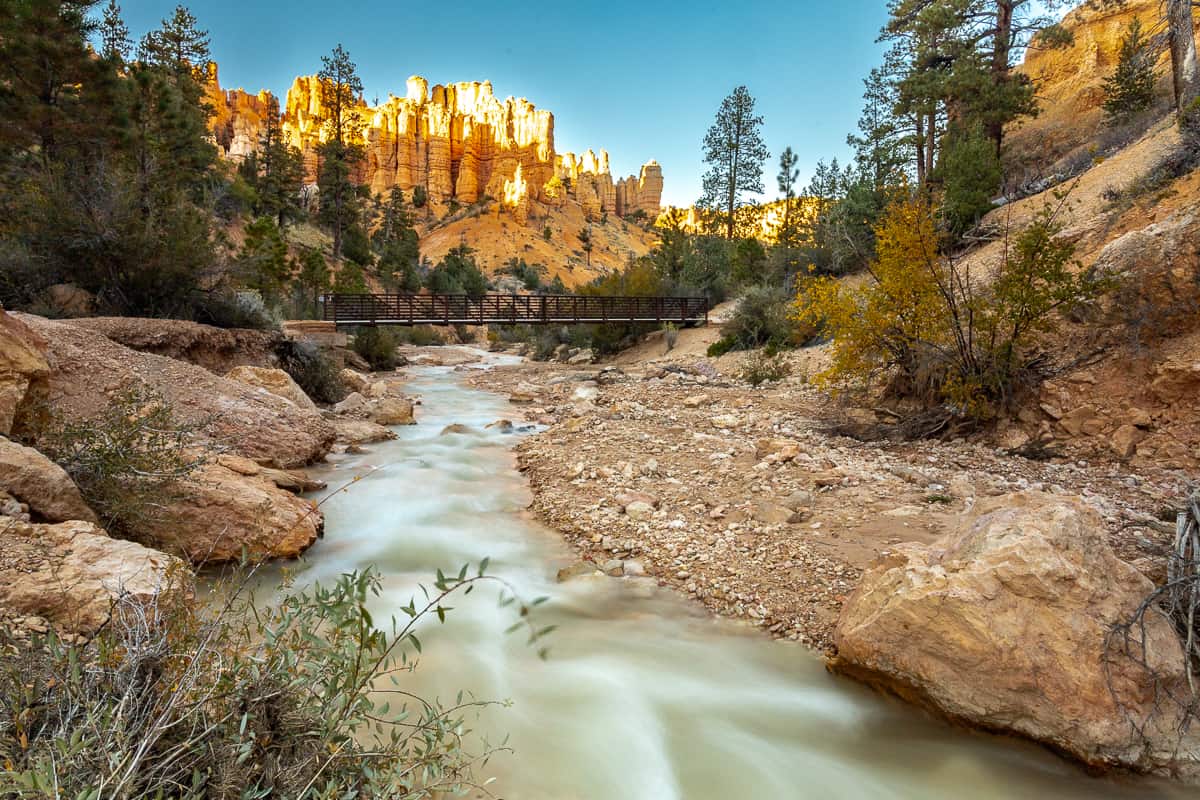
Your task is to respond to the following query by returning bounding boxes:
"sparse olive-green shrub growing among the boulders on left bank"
[37,387,205,540]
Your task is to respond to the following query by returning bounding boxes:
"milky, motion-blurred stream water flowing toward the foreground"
[278,357,1182,800]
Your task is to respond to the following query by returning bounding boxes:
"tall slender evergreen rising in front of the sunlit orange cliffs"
[317,44,362,259]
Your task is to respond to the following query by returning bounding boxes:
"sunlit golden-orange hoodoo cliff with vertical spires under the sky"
[201,65,662,218]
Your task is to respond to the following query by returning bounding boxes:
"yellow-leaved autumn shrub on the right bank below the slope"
[794,194,1109,419]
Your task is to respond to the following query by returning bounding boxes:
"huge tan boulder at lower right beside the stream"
[832,493,1200,772]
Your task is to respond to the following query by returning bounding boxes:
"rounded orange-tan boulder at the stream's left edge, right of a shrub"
[152,459,324,565]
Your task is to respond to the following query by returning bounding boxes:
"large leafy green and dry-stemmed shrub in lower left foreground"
[0,563,548,800]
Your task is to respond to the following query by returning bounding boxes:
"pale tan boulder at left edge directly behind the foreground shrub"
[0,519,191,634]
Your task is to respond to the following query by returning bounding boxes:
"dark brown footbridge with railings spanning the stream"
[322,294,708,327]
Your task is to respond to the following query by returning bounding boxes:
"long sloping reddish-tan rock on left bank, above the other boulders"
[14,314,334,468]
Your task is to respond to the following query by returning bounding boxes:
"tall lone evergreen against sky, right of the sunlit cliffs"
[700,86,769,239]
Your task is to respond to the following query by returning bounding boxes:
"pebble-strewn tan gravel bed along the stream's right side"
[472,356,1187,651]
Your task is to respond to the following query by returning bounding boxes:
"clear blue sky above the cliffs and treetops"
[114,0,886,205]
